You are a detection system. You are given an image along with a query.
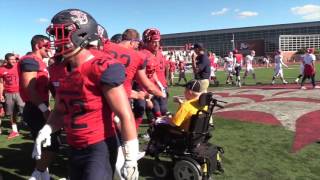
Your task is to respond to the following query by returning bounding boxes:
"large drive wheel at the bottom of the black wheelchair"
[173,160,202,180]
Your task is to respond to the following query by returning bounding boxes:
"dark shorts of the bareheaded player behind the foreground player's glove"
[22,102,61,152]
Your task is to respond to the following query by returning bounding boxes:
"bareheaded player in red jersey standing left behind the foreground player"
[18,35,59,180]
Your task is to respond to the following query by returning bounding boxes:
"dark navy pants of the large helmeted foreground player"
[70,138,118,180]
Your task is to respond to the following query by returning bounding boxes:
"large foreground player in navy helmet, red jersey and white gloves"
[33,9,139,180]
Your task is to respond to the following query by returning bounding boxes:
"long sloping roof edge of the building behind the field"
[161,21,320,39]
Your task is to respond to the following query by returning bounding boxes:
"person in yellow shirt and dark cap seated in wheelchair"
[147,80,208,154]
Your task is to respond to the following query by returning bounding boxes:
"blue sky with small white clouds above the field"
[0,0,320,59]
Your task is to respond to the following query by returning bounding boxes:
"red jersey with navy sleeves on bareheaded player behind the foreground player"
[18,55,49,102]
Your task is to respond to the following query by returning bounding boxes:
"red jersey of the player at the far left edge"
[0,64,19,93]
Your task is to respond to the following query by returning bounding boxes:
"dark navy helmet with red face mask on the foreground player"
[47,9,100,56]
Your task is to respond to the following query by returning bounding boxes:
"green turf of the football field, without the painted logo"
[0,64,320,180]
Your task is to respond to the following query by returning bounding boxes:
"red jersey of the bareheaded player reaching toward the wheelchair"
[103,41,145,97]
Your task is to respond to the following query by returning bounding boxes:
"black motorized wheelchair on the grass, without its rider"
[146,92,225,180]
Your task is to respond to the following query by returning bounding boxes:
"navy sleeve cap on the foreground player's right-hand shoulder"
[100,63,126,87]
